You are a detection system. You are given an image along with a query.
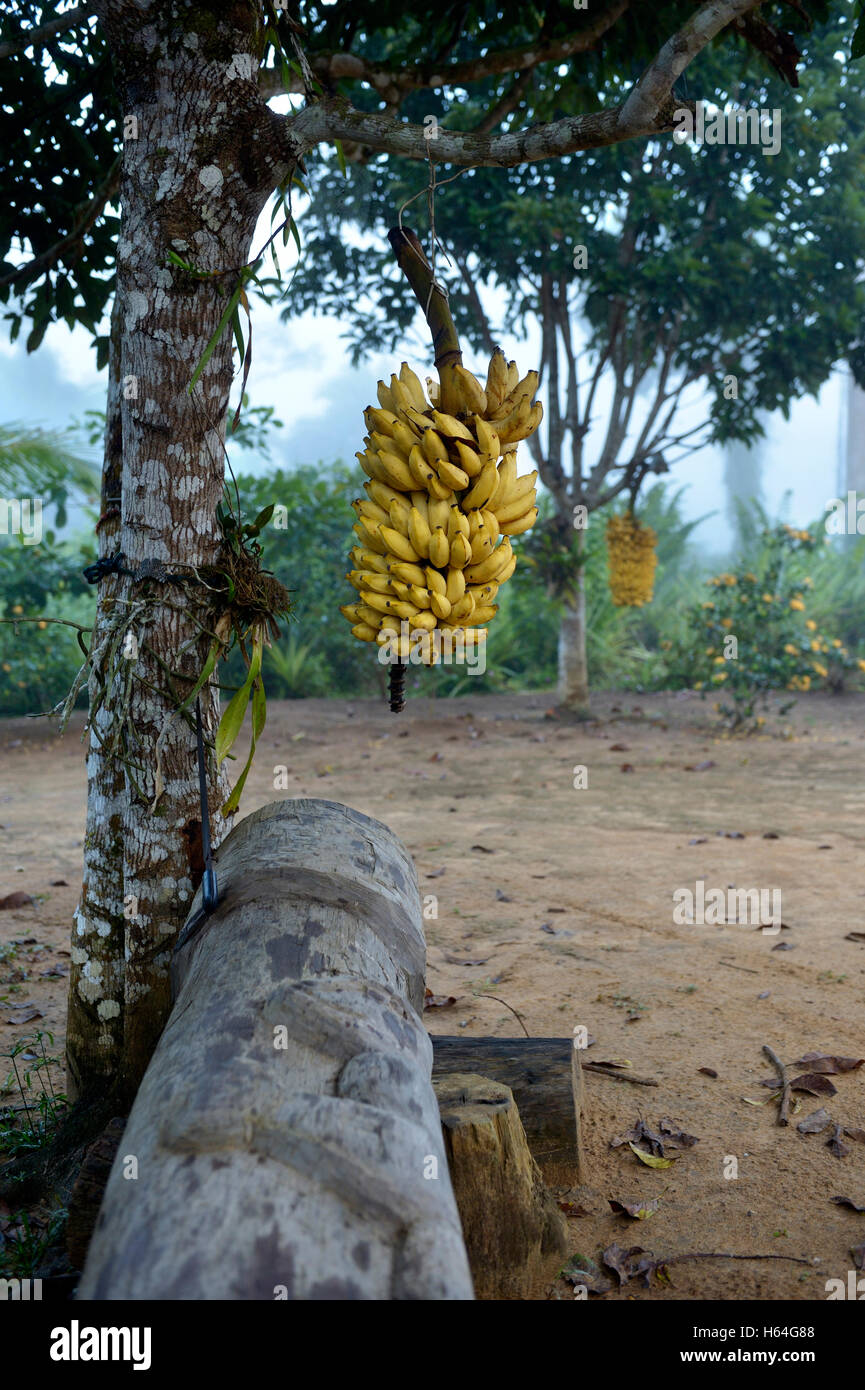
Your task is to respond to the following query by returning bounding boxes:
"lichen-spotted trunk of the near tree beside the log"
[70,0,284,1098]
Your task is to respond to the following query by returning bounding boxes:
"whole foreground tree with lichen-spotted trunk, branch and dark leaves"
[0,0,845,1097]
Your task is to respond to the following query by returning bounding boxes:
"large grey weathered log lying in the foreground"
[78,799,473,1301]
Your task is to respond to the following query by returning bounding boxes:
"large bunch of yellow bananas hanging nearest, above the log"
[339,349,542,660]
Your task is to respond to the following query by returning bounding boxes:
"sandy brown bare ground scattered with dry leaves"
[0,694,865,1300]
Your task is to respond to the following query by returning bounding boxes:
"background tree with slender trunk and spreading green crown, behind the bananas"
[284,7,865,710]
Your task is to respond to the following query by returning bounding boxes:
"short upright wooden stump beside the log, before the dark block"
[433,1072,567,1298]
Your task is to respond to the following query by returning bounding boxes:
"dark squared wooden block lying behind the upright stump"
[433,1037,587,1187]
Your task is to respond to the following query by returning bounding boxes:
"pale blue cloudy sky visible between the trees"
[0,202,844,553]
